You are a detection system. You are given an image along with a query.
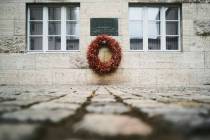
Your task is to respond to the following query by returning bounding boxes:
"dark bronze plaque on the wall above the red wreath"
[90,18,118,36]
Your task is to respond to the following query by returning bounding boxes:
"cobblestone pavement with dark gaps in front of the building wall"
[0,85,210,140]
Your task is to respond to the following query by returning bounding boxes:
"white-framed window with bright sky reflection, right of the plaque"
[129,6,180,51]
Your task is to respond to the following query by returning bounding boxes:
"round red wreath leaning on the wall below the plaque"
[87,35,122,74]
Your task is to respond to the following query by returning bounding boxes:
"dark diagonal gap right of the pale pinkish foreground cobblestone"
[106,88,186,140]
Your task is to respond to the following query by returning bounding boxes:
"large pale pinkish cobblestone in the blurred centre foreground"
[74,114,152,136]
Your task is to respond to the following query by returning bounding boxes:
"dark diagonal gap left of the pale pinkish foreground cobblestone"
[39,88,98,140]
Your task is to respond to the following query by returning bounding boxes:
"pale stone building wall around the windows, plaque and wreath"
[0,0,210,87]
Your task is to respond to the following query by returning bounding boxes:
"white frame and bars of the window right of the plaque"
[128,3,182,52]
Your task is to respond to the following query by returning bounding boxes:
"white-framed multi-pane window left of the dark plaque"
[28,5,79,52]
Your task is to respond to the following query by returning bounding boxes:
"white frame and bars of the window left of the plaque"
[26,3,81,53]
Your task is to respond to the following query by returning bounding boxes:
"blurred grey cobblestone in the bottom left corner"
[0,124,38,140]
